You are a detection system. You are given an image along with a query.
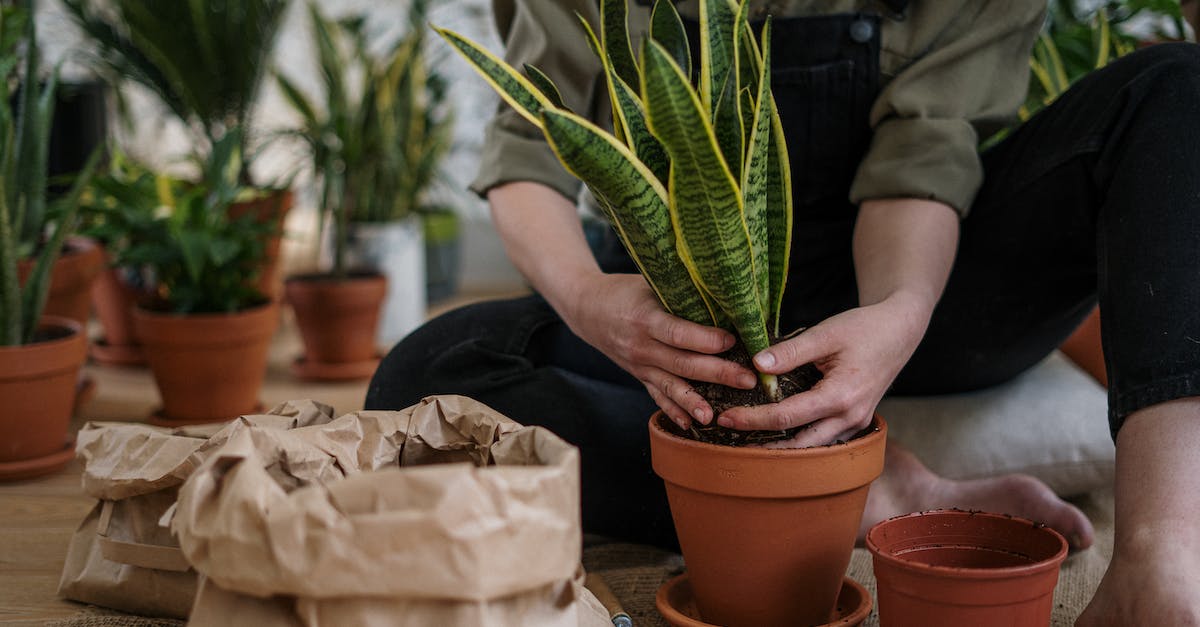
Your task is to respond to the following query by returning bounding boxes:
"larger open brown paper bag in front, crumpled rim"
[172,396,611,627]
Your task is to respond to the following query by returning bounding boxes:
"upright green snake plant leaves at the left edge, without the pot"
[0,0,98,346]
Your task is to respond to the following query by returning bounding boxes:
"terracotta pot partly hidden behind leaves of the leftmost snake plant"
[17,237,104,328]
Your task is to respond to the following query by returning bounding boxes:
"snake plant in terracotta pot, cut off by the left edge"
[0,0,98,479]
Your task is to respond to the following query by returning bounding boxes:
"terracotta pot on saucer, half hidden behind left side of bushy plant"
[89,252,145,365]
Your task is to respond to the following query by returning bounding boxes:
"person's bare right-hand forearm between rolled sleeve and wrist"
[853,198,959,321]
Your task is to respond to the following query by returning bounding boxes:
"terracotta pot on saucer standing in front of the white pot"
[284,273,388,380]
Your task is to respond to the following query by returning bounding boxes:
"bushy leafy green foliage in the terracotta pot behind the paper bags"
[78,131,271,314]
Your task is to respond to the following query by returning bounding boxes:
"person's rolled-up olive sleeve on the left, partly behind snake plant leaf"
[470,0,607,202]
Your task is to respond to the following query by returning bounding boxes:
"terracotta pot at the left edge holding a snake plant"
[0,316,88,479]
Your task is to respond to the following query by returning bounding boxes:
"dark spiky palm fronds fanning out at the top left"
[64,0,288,183]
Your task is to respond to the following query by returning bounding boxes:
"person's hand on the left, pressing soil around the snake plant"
[560,274,757,429]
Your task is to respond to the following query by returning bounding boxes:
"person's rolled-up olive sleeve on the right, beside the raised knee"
[850,0,1045,216]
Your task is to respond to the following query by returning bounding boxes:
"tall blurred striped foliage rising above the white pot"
[276,0,451,276]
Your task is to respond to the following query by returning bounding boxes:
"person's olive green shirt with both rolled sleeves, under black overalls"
[472,0,1045,215]
